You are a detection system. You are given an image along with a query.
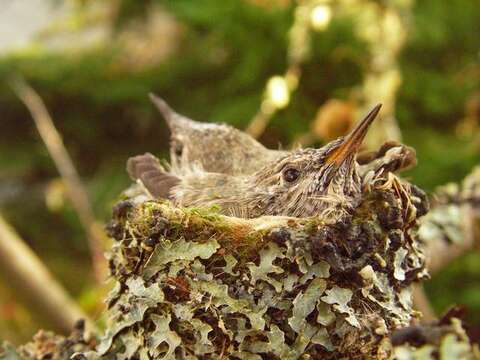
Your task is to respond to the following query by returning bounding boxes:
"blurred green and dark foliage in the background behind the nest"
[0,0,480,344]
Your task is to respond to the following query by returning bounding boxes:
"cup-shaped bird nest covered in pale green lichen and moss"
[78,173,427,359]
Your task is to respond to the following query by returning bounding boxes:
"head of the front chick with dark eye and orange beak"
[254,105,381,217]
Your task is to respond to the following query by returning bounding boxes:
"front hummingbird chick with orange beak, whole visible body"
[127,104,381,218]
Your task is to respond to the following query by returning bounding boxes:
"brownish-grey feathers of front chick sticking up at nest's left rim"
[127,153,180,199]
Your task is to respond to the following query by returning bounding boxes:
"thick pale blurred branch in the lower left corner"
[0,215,94,332]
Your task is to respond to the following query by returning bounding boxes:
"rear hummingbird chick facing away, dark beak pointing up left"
[150,94,287,175]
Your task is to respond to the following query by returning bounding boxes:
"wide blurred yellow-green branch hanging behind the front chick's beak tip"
[350,1,413,150]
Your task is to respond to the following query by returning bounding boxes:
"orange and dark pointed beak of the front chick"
[326,104,382,166]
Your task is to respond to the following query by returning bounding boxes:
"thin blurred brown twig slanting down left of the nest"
[12,79,106,282]
